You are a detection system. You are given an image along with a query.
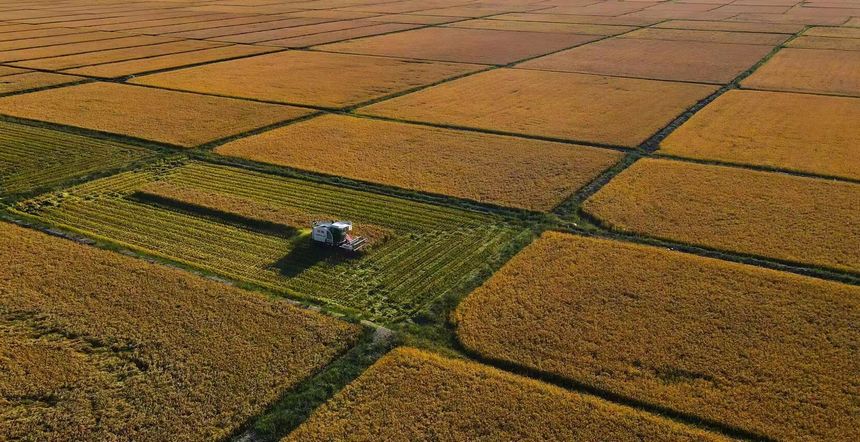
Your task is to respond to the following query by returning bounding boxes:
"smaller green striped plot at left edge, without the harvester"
[0,122,154,195]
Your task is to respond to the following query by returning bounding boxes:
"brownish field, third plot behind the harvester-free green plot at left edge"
[320,27,598,64]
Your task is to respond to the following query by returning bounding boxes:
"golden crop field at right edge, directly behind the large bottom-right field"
[583,159,860,273]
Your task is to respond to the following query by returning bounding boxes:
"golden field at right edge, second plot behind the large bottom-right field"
[660,90,860,179]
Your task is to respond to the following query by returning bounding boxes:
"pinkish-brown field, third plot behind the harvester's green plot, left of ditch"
[519,38,773,83]
